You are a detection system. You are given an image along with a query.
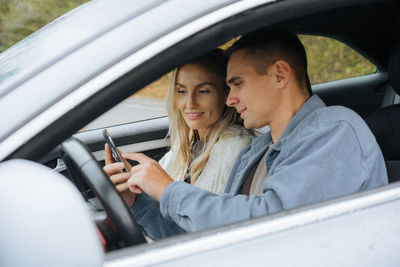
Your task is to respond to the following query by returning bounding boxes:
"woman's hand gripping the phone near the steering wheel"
[103,144,143,207]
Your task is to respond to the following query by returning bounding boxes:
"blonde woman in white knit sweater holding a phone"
[104,49,252,203]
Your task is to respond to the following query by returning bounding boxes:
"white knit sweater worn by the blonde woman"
[160,126,252,194]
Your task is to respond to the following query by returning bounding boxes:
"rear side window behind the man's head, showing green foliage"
[299,35,377,84]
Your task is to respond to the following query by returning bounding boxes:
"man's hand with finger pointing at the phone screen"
[123,153,173,201]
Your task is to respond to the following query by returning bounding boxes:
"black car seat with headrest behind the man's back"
[365,42,400,183]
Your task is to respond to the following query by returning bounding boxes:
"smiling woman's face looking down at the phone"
[175,64,227,138]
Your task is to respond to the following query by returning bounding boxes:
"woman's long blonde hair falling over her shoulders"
[167,49,248,184]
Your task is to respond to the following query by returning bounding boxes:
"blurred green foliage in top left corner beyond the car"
[0,0,88,52]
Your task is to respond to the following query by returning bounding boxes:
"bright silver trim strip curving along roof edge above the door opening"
[0,0,276,160]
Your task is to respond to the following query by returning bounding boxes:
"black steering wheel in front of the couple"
[61,137,146,246]
